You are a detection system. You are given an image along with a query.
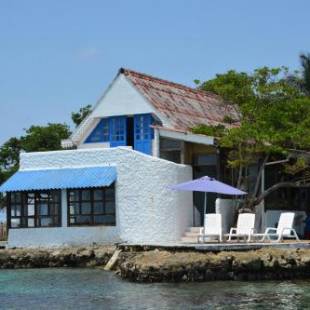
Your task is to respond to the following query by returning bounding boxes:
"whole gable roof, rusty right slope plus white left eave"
[62,68,240,148]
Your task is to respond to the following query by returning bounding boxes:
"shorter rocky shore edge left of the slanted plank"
[0,246,115,269]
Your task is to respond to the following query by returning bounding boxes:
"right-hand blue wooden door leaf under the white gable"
[134,114,154,155]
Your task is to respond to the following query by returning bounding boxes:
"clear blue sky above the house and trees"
[0,0,310,144]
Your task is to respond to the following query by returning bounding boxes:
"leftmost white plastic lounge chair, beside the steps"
[198,213,223,243]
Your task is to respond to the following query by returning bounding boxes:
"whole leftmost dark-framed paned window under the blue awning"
[8,191,61,228]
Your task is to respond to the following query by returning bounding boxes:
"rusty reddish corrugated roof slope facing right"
[120,68,240,131]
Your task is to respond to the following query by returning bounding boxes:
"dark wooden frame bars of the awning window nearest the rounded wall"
[67,183,116,227]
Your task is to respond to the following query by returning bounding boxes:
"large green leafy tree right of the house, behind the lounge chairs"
[193,67,310,208]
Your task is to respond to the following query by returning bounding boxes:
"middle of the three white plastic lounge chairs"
[225,213,255,242]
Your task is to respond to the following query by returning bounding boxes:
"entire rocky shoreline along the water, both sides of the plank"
[0,245,310,283]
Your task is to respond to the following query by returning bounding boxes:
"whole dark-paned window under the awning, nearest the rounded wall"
[68,185,115,226]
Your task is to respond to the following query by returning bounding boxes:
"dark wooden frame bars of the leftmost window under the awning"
[7,190,61,229]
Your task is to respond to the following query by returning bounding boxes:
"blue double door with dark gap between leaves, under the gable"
[109,114,154,154]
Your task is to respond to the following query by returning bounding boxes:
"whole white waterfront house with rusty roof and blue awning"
[0,69,239,247]
